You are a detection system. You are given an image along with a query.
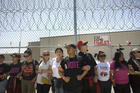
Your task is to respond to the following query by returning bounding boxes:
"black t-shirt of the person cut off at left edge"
[0,63,10,80]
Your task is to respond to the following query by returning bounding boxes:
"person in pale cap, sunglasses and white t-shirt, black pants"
[37,50,52,93]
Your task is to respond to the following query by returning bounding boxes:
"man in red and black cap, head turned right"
[77,41,97,93]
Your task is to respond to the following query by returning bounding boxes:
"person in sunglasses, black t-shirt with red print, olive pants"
[21,48,39,93]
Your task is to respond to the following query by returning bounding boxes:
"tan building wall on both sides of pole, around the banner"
[40,31,140,60]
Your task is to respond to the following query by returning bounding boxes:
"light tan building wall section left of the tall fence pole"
[40,36,74,58]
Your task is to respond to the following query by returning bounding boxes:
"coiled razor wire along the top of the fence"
[0,0,140,32]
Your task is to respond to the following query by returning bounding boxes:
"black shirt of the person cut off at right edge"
[128,59,140,86]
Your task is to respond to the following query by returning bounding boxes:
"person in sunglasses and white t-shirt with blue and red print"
[97,51,111,93]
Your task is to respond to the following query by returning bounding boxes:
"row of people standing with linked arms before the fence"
[0,41,140,93]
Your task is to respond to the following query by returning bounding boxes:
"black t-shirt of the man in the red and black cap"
[78,52,97,77]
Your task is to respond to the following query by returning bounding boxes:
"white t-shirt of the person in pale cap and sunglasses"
[37,61,51,84]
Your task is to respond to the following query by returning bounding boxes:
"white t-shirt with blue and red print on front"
[97,62,110,81]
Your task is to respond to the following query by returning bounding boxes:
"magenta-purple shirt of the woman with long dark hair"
[110,61,129,84]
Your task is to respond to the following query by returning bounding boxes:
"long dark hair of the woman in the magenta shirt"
[113,51,128,69]
